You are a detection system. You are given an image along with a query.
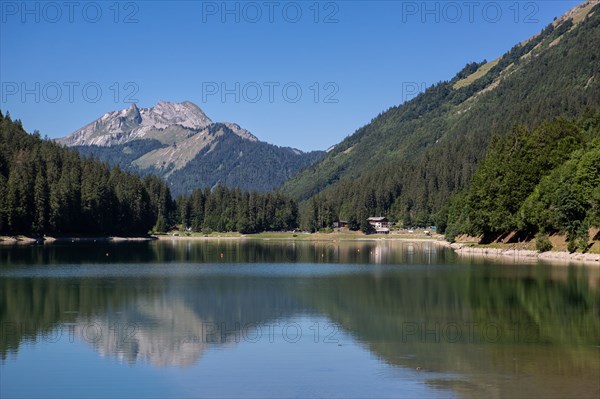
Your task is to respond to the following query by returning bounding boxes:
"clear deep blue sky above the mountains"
[0,0,581,150]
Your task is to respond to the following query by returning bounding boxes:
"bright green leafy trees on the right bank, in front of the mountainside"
[442,111,600,250]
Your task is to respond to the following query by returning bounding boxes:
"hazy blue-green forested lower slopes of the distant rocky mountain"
[72,124,324,196]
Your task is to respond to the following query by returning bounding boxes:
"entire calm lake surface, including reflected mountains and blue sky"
[0,241,600,398]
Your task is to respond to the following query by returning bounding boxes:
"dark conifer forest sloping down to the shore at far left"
[0,113,171,235]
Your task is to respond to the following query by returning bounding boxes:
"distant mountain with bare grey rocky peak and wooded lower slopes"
[57,101,324,195]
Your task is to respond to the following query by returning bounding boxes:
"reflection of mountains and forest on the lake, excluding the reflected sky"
[0,241,600,397]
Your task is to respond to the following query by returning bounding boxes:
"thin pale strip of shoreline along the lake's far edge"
[0,232,600,266]
